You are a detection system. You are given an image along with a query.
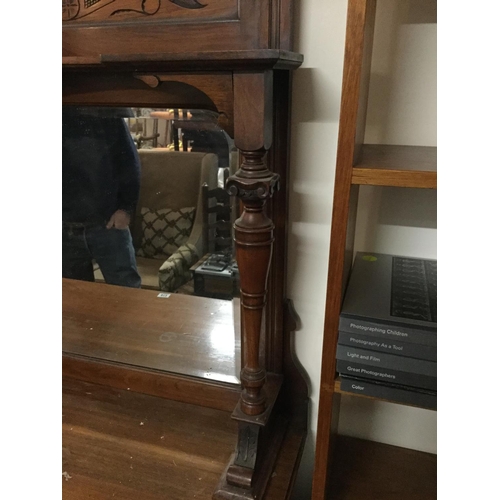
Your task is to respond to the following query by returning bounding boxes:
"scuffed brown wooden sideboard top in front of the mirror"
[62,379,237,500]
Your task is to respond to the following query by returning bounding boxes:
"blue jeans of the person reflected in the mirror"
[62,223,141,288]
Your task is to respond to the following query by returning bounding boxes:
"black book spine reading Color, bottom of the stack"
[340,377,437,410]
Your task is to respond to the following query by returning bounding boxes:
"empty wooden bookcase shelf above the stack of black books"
[351,144,437,189]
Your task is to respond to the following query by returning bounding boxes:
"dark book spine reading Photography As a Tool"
[339,332,437,361]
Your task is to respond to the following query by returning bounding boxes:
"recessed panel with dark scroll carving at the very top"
[62,0,239,25]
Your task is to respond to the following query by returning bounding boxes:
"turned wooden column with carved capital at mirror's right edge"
[227,71,279,415]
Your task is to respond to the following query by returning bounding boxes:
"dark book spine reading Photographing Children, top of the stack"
[339,314,437,346]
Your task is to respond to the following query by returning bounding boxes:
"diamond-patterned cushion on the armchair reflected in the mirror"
[137,207,196,259]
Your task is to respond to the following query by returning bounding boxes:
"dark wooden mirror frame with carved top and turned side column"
[63,0,307,499]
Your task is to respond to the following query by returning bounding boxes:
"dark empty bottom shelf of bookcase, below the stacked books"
[327,436,437,500]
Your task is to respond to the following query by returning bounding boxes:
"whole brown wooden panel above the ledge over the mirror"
[62,0,291,58]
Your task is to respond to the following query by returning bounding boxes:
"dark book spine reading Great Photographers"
[337,359,437,391]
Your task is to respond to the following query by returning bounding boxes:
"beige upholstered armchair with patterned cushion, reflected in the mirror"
[131,148,218,292]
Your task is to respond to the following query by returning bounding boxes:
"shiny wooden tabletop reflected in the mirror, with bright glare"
[62,279,241,384]
